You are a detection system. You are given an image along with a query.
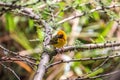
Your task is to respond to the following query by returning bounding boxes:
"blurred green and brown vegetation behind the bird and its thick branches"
[0,0,120,80]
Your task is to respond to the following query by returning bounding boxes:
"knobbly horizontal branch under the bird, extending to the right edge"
[51,41,120,56]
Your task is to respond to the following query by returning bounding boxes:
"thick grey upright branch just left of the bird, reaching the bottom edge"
[34,21,51,80]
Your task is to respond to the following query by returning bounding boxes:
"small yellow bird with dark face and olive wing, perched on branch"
[49,30,67,48]
